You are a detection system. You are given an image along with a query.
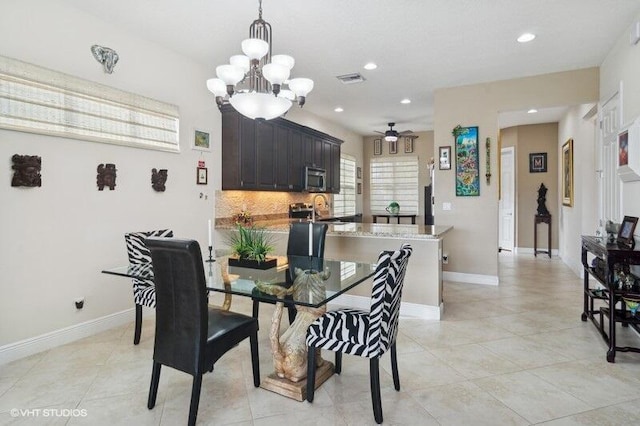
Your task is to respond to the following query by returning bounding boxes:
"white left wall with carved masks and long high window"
[0,0,221,347]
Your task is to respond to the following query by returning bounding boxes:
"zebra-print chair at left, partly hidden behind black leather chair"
[124,229,173,345]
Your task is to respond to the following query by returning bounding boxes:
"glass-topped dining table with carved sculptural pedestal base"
[102,256,376,401]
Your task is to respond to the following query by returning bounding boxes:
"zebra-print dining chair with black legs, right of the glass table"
[306,244,412,423]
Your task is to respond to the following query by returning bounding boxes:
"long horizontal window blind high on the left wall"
[0,56,180,152]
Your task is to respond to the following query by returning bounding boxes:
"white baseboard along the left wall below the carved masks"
[0,309,135,365]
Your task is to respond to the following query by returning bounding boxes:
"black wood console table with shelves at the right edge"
[582,236,640,362]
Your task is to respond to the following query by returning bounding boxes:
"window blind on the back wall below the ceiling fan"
[369,156,419,214]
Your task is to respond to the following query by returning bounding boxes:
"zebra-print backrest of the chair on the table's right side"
[366,244,412,357]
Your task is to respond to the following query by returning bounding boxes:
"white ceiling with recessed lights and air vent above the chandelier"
[61,0,640,135]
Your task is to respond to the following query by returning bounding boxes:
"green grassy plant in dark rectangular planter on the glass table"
[229,224,277,269]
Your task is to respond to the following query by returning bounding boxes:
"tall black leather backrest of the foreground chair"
[147,238,208,375]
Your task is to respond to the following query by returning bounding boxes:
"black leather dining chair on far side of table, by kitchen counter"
[252,222,329,324]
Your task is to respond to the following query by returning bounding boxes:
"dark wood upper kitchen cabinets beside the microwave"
[222,106,342,193]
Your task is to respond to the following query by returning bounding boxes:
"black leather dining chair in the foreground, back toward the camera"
[147,238,260,425]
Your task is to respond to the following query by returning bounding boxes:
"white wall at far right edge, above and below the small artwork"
[600,15,640,223]
